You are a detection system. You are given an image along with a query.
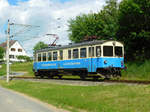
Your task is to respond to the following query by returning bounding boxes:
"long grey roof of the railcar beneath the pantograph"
[36,40,108,52]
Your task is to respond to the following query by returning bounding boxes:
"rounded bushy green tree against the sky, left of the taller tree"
[68,14,97,42]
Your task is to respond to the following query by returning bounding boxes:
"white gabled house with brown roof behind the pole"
[0,40,28,62]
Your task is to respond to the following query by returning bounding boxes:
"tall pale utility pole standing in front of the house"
[6,20,10,82]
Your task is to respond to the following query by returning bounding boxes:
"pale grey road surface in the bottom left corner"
[0,87,67,112]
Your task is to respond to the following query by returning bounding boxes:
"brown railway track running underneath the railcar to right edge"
[11,76,150,85]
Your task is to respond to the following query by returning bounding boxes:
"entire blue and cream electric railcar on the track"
[33,40,124,79]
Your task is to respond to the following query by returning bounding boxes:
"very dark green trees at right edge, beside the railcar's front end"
[117,0,150,60]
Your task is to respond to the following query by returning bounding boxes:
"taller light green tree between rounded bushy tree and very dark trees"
[97,0,119,39]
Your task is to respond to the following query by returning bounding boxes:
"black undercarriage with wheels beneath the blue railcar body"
[34,68,121,80]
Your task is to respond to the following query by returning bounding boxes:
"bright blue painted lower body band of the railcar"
[33,57,124,72]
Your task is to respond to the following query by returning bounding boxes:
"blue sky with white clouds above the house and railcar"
[0,0,105,56]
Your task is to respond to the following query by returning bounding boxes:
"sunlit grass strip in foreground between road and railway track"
[0,81,150,112]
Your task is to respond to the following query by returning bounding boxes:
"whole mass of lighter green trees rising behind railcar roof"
[68,0,118,42]
